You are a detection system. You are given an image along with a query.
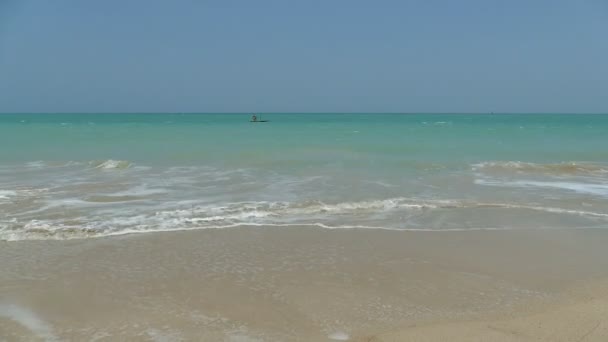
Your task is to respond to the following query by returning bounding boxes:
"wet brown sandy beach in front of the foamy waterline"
[0,227,608,341]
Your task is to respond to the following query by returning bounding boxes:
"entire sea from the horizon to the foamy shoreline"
[0,114,608,240]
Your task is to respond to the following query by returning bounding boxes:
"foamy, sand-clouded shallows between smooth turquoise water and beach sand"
[0,159,608,240]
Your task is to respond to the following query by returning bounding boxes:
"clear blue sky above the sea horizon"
[0,0,608,113]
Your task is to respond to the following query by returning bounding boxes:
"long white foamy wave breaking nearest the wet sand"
[0,198,608,241]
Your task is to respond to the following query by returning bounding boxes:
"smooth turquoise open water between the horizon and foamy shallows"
[0,114,608,165]
